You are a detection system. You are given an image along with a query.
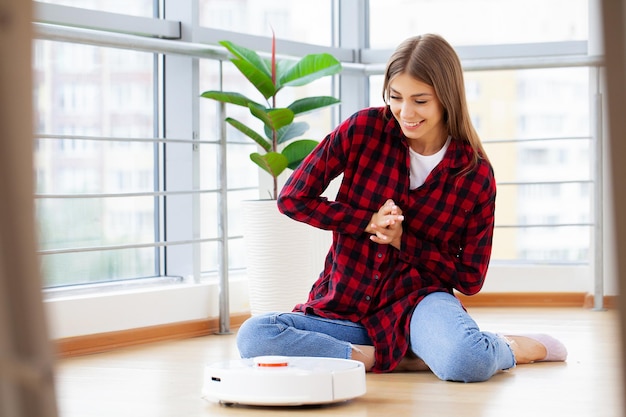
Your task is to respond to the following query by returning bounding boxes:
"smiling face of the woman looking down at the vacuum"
[389,73,448,155]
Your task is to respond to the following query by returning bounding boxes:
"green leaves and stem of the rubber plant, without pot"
[201,37,342,200]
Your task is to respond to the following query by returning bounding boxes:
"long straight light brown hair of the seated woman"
[383,34,488,175]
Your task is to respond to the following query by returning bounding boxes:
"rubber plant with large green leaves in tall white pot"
[201,37,342,315]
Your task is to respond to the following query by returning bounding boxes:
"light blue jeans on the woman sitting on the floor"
[237,292,515,382]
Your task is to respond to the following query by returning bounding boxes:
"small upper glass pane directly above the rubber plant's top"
[199,0,332,46]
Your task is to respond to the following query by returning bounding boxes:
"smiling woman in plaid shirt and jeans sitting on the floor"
[237,34,567,382]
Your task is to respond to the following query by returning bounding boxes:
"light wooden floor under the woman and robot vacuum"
[57,308,624,417]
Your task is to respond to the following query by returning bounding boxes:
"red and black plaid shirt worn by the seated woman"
[278,107,496,372]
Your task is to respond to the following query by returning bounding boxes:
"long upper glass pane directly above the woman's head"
[370,0,589,49]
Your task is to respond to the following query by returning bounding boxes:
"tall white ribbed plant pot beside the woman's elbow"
[242,200,332,315]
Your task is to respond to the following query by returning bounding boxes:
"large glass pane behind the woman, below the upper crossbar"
[371,68,594,262]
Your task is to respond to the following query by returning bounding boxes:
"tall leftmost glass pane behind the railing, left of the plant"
[34,41,157,286]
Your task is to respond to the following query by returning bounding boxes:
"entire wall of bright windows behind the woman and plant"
[34,0,599,287]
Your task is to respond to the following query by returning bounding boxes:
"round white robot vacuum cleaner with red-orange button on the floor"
[202,356,366,406]
